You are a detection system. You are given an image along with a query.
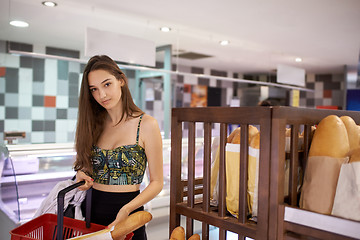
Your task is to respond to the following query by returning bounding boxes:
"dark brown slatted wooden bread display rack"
[169,106,360,240]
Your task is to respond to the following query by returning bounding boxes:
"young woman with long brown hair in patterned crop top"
[74,55,163,240]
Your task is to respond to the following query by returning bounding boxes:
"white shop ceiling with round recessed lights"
[0,0,360,73]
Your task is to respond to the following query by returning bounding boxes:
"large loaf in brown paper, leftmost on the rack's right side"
[309,115,350,158]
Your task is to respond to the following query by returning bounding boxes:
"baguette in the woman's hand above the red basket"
[111,211,152,240]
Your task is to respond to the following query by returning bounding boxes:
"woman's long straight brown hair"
[74,55,144,174]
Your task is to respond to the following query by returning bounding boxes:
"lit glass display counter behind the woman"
[0,139,203,239]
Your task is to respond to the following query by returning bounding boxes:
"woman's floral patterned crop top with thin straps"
[91,115,147,185]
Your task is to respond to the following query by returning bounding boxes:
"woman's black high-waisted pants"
[81,189,147,240]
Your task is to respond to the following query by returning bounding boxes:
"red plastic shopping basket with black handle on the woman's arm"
[10,181,134,240]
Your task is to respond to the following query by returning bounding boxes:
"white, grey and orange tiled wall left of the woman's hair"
[0,40,82,143]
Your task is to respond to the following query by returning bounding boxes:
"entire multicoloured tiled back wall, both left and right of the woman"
[0,40,344,143]
